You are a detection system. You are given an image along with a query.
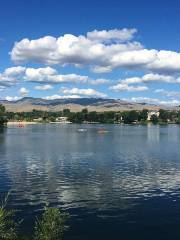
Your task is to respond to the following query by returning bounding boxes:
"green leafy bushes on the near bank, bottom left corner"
[0,197,68,240]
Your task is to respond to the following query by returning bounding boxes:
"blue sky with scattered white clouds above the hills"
[0,0,180,105]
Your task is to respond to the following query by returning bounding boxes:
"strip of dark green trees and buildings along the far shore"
[0,105,180,125]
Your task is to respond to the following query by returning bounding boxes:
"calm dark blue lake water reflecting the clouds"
[0,124,180,240]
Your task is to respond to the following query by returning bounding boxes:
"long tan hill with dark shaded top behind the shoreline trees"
[0,97,177,112]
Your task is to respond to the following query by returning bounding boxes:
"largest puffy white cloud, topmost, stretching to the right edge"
[10,29,180,74]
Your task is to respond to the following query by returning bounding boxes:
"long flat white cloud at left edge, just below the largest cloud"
[0,66,110,86]
